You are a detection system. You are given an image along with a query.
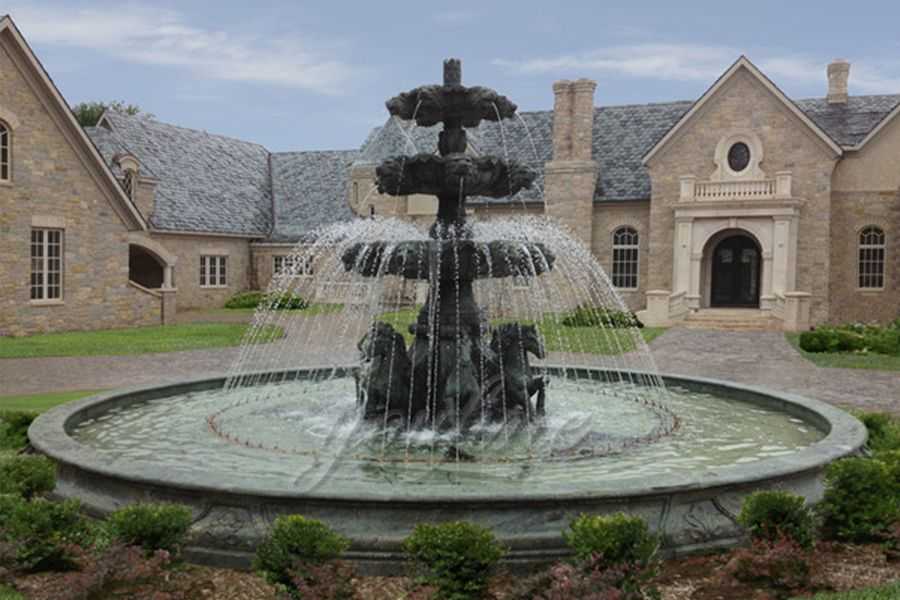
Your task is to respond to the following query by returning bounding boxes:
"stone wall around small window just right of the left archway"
[149,232,251,310]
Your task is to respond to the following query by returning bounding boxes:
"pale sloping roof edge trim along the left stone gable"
[0,15,147,230]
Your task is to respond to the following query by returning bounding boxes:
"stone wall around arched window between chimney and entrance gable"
[591,201,648,310]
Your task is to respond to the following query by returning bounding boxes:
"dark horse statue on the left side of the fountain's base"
[355,321,412,420]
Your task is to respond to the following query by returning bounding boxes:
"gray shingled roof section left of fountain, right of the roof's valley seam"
[269,150,359,242]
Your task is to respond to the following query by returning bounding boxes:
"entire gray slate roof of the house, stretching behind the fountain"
[86,87,900,242]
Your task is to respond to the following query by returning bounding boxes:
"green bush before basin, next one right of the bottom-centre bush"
[563,513,659,565]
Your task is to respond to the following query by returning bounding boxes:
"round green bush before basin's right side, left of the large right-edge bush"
[738,491,815,549]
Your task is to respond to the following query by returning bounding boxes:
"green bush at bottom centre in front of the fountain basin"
[403,521,506,600]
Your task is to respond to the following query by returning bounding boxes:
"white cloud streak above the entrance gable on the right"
[493,43,900,94]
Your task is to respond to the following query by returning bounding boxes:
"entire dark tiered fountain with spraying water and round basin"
[29,60,865,573]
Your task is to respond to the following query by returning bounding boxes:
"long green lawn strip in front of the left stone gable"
[0,323,284,359]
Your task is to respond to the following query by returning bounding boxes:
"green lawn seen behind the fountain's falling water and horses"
[379,309,665,355]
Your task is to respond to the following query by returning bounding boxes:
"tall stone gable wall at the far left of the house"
[0,38,161,335]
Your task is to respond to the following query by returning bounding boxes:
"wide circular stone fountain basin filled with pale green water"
[29,369,865,572]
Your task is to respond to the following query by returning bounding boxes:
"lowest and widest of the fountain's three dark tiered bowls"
[341,240,555,280]
